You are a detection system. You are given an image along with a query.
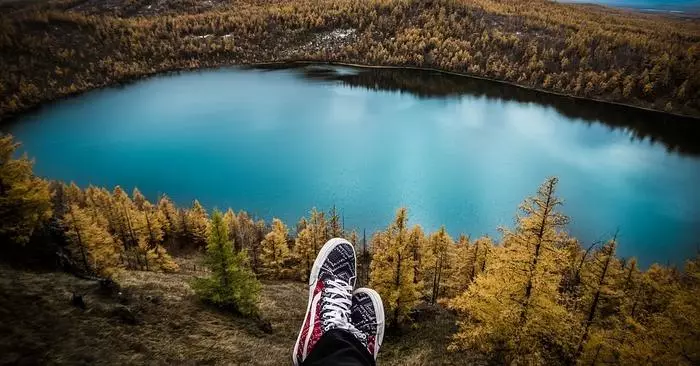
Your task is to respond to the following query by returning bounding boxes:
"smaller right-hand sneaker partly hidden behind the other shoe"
[350,287,384,360]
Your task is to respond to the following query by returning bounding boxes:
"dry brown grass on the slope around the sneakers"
[0,259,464,365]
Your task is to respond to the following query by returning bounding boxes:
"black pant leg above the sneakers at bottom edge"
[303,329,376,366]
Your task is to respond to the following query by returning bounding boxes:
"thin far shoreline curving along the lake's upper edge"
[0,59,700,127]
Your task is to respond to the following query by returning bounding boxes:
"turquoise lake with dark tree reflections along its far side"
[3,66,700,265]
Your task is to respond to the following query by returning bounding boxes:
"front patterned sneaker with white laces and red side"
[292,238,357,366]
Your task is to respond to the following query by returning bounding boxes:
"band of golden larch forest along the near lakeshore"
[0,135,700,365]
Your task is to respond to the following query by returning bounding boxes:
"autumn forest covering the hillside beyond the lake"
[0,0,700,119]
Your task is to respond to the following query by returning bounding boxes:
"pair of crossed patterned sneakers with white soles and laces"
[292,238,384,366]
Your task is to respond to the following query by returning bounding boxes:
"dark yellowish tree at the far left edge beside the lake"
[0,135,51,245]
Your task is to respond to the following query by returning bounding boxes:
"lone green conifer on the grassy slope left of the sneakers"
[193,211,261,315]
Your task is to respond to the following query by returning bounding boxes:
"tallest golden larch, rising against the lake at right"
[450,178,575,363]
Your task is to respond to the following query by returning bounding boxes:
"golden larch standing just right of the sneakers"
[369,208,419,327]
